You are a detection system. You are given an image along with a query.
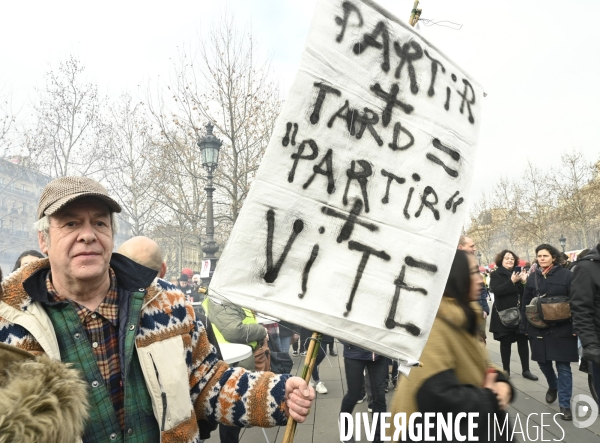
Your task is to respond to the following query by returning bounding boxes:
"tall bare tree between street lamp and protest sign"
[198,15,281,229]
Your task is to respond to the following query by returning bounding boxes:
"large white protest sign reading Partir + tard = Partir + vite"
[210,0,483,372]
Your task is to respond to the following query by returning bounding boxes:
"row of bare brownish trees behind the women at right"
[467,156,600,261]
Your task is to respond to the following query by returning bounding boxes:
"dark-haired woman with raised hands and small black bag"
[490,249,538,380]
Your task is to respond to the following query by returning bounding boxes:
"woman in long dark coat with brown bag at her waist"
[521,244,579,421]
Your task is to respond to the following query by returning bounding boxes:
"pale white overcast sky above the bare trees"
[0,0,600,208]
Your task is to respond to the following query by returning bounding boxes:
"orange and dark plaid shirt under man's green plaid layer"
[46,268,125,429]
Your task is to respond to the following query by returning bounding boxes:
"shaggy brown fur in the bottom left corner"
[0,343,89,443]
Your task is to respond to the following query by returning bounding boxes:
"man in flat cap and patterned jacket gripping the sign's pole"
[0,177,314,443]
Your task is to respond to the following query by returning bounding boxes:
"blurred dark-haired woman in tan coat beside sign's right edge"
[388,250,513,441]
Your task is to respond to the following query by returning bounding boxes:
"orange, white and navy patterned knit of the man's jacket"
[0,254,290,442]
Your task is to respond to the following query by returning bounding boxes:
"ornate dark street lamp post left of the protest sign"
[198,122,222,283]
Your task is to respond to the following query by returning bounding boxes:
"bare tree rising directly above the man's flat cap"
[32,57,106,177]
